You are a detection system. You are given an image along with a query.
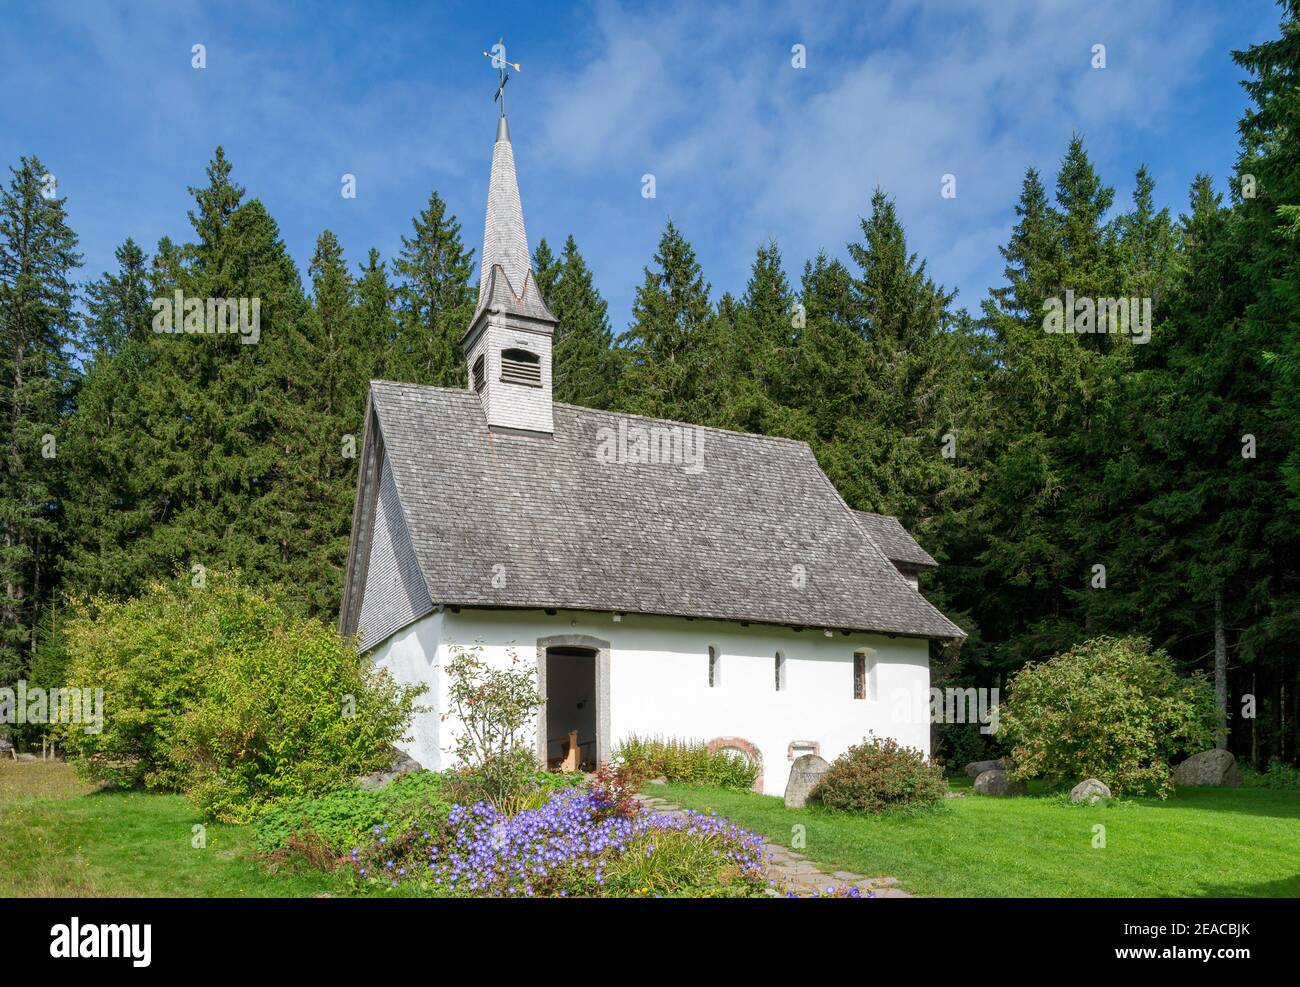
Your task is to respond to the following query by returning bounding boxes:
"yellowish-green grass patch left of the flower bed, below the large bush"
[0,761,342,897]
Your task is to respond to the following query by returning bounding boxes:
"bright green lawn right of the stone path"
[654,779,1300,897]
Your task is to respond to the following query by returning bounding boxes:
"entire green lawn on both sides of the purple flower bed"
[10,762,1300,897]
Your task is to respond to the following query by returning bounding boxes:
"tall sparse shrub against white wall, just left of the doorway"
[443,648,543,805]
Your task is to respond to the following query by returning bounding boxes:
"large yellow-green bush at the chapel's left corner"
[62,572,423,822]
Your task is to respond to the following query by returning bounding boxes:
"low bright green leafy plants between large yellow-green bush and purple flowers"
[254,771,451,857]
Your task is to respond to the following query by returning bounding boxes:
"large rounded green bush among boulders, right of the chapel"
[1001,637,1219,798]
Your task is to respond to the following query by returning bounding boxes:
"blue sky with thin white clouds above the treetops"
[0,0,1278,330]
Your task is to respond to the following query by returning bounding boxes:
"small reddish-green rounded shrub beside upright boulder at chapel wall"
[813,737,948,813]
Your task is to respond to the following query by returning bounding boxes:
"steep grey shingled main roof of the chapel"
[343,381,965,644]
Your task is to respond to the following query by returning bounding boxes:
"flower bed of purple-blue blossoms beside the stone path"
[352,789,767,897]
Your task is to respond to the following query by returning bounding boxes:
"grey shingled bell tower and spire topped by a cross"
[460,44,556,434]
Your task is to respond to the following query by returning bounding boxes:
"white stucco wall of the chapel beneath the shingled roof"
[374,610,930,795]
